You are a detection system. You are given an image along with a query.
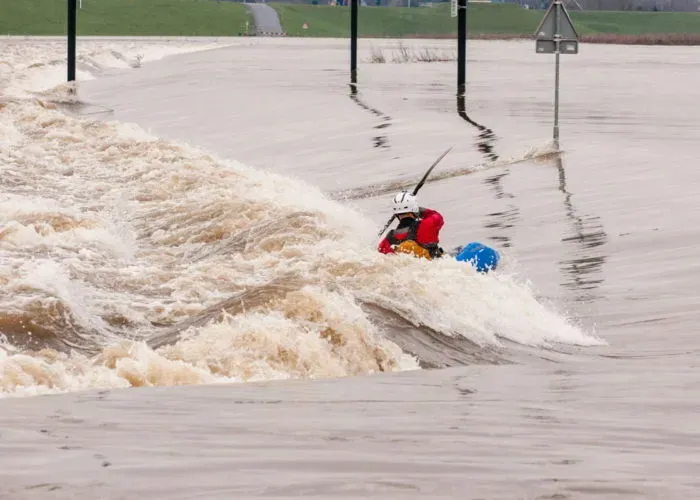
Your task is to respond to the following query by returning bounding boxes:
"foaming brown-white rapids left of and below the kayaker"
[0,41,605,395]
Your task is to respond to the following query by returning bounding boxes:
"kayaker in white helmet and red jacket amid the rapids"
[378,191,445,259]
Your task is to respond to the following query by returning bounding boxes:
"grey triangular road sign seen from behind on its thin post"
[535,0,578,149]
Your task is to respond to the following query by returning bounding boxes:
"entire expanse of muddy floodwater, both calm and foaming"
[0,39,700,499]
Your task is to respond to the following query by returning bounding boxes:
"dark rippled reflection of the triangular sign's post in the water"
[555,155,608,302]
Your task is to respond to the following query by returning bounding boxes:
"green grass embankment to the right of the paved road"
[271,3,700,45]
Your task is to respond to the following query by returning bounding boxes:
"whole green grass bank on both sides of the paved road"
[0,0,700,39]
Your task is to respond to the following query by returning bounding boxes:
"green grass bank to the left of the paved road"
[0,0,255,36]
